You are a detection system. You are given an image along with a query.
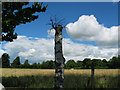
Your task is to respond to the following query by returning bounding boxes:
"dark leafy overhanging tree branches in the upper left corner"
[2,2,47,41]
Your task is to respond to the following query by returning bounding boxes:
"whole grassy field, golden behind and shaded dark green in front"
[2,69,120,88]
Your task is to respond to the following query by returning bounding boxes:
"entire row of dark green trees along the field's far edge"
[1,53,120,69]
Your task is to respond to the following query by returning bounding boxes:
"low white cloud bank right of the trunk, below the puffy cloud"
[63,39,118,60]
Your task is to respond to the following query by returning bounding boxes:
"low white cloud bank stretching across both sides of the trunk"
[0,36,118,63]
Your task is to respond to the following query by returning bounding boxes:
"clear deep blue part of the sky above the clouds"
[15,2,118,38]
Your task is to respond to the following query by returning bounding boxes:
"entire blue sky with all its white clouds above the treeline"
[0,2,119,63]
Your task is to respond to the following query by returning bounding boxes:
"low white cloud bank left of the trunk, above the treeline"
[3,36,53,62]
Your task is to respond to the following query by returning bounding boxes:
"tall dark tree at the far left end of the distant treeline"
[2,53,10,68]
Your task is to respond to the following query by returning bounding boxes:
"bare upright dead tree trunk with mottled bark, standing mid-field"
[54,25,65,88]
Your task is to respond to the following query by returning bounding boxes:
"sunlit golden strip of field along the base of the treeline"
[1,68,119,77]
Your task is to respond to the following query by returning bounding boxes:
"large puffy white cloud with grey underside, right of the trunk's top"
[66,15,118,47]
